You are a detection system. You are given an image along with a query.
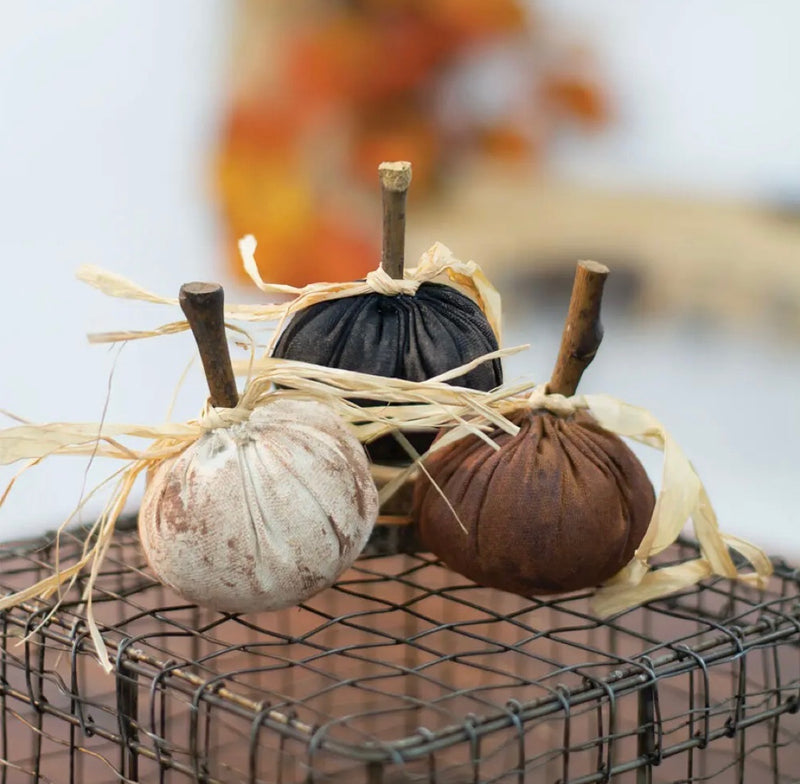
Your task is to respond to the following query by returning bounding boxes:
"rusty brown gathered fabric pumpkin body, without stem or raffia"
[414,409,655,596]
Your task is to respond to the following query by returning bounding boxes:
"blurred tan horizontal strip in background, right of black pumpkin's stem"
[406,167,800,335]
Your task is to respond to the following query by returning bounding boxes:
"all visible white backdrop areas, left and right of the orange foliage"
[0,0,800,551]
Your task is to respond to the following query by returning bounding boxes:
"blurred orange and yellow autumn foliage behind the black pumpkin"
[217,0,607,285]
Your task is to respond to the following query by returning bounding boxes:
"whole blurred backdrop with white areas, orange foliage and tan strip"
[0,0,800,557]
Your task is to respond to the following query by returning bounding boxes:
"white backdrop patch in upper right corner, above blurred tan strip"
[538,0,800,199]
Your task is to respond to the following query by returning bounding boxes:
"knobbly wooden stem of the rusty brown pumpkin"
[547,261,608,397]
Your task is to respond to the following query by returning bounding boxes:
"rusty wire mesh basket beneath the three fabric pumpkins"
[0,532,800,784]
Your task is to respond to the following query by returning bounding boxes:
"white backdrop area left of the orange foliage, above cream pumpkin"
[0,0,232,538]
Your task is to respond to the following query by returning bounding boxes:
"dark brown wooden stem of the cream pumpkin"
[178,283,239,408]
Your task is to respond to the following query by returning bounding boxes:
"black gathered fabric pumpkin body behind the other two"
[273,283,503,462]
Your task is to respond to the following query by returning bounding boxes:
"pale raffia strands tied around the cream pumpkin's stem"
[0,349,525,671]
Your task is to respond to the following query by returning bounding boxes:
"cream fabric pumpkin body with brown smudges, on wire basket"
[139,400,378,612]
